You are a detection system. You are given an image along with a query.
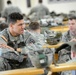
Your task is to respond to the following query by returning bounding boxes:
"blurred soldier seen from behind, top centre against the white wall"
[28,0,50,21]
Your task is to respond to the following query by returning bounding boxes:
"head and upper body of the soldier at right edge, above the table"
[62,16,76,42]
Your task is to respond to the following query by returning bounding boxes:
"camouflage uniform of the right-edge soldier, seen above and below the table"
[58,31,71,63]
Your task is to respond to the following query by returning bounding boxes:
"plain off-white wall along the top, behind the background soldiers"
[3,0,76,14]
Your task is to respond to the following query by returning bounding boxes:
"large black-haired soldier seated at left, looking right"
[0,12,43,70]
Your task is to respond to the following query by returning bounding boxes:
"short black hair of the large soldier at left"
[7,12,23,24]
